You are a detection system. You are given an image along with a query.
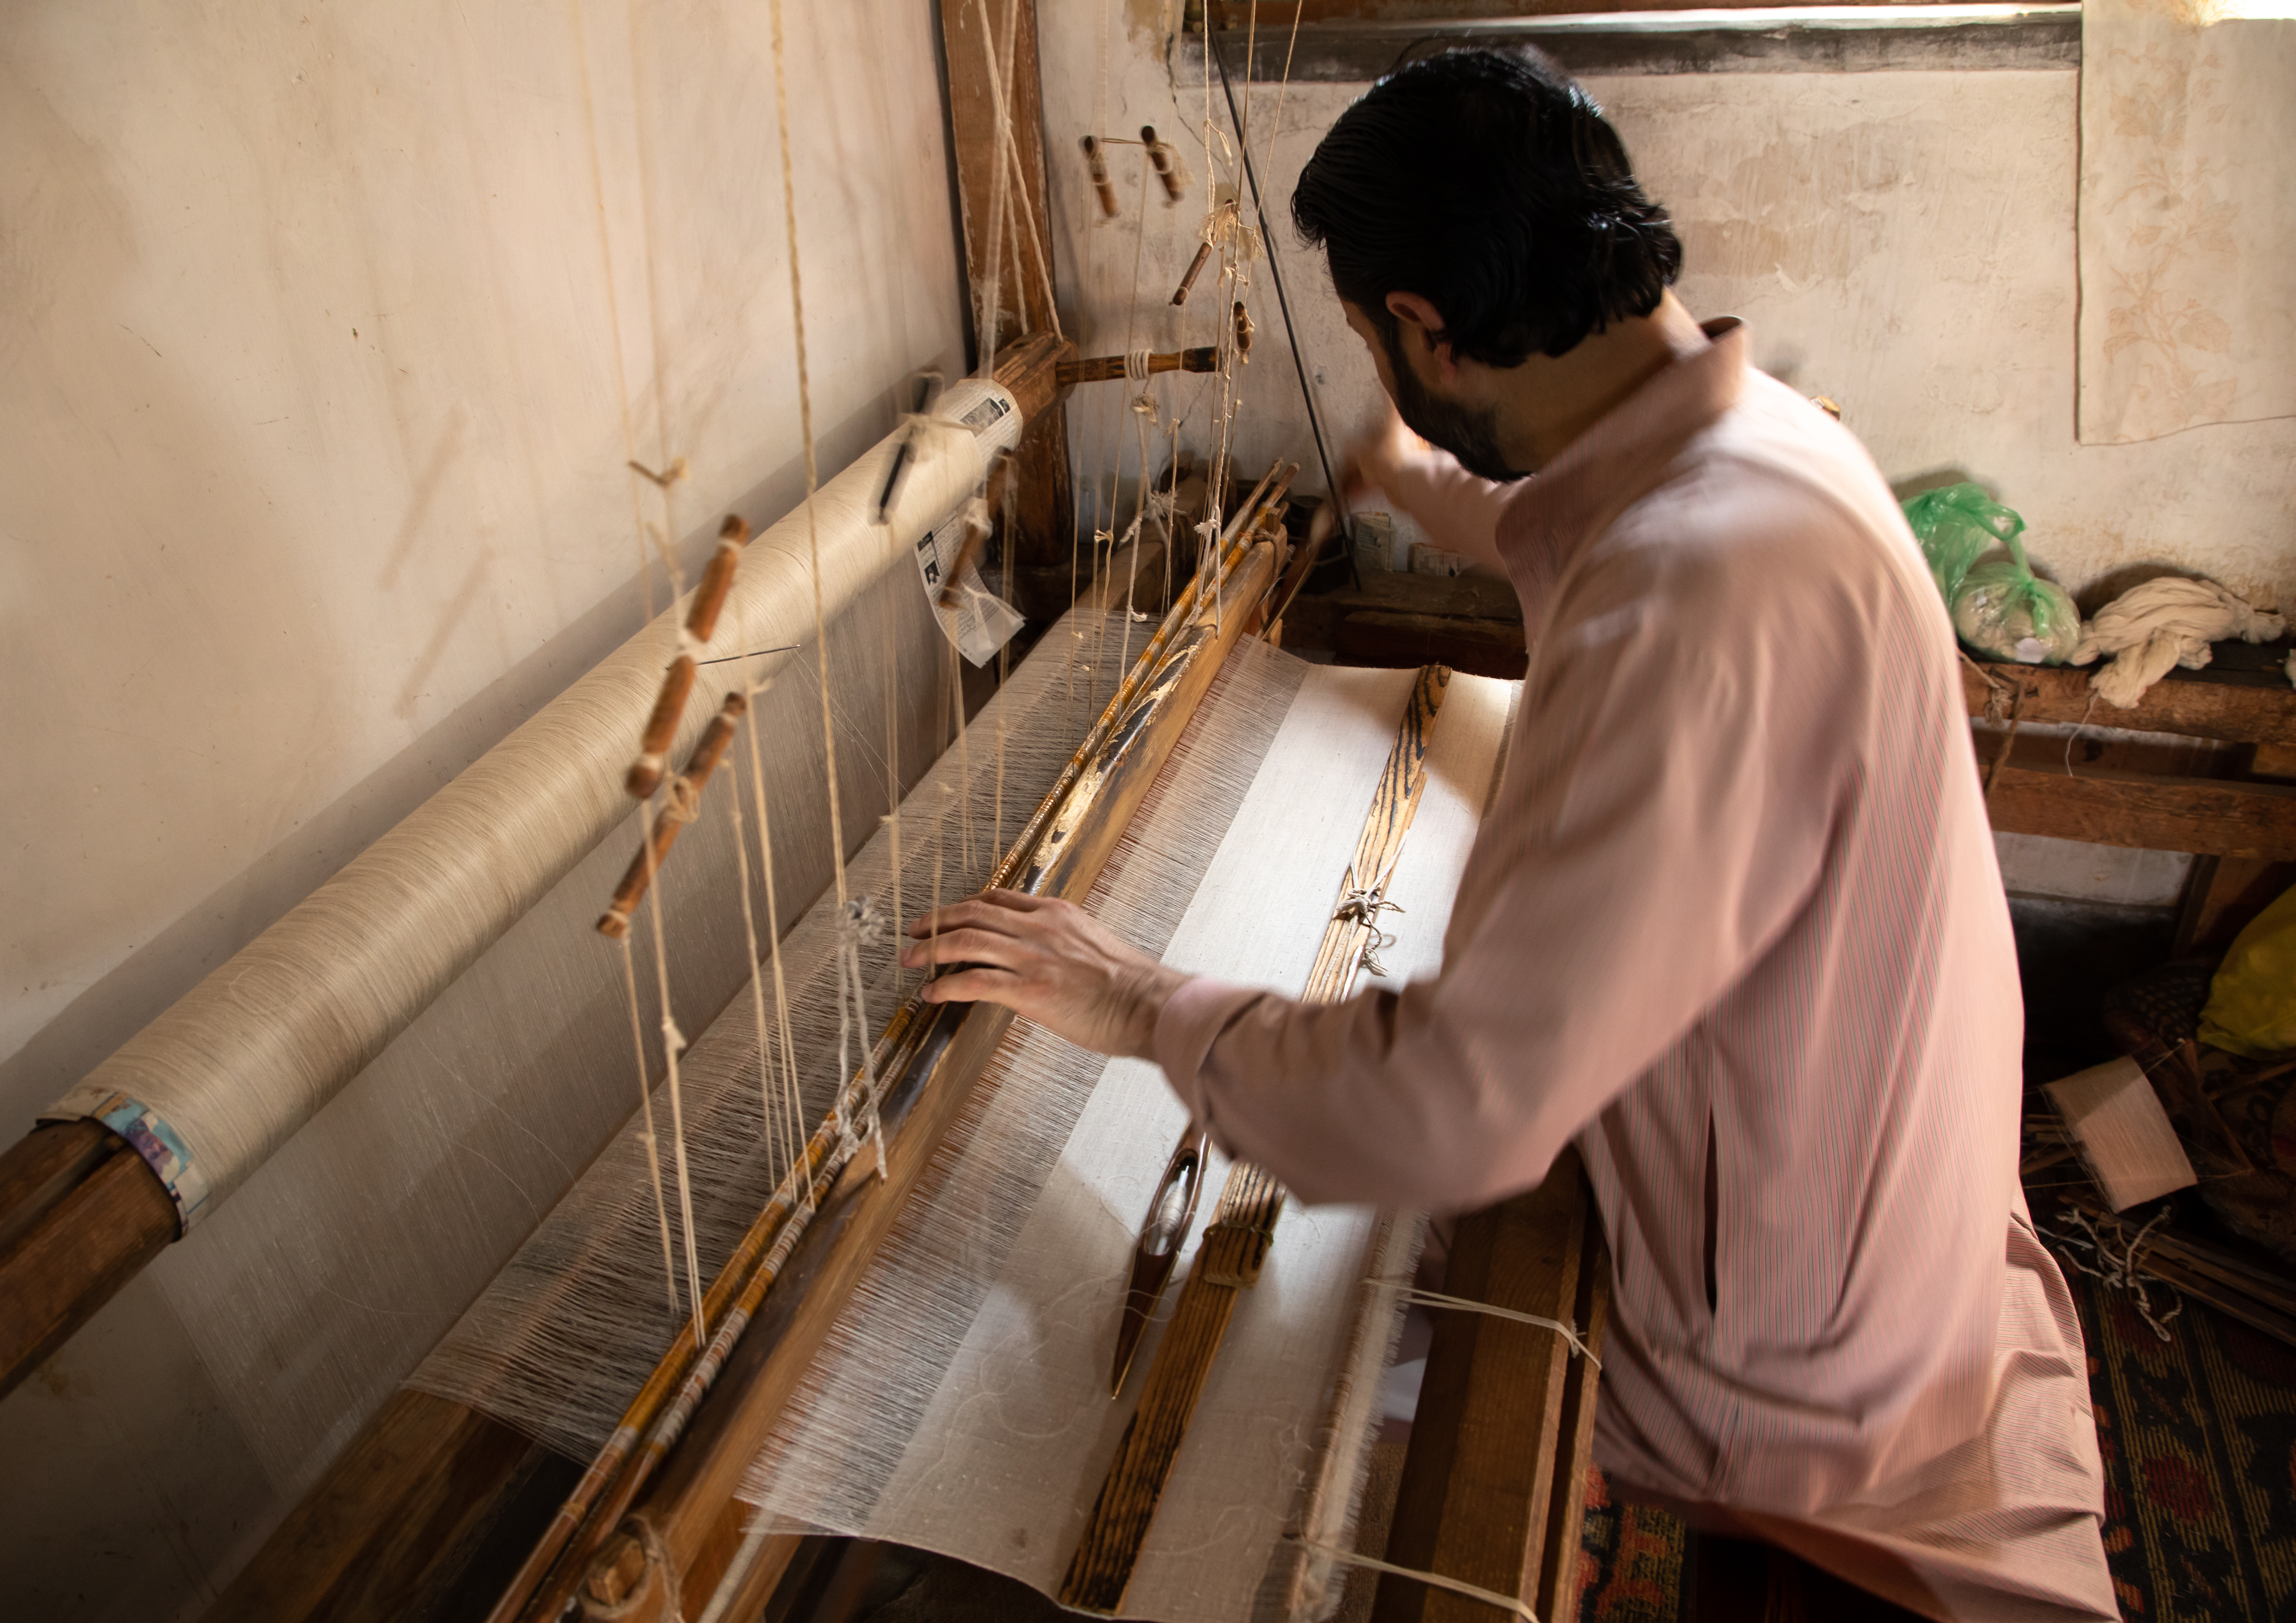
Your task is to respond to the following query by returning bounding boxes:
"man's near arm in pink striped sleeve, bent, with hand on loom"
[907,498,1860,1210]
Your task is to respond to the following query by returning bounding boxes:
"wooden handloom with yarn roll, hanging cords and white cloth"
[5,0,1616,1618]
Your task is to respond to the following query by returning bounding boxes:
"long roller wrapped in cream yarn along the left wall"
[51,399,1019,1226]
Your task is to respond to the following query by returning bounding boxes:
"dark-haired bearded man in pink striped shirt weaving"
[907,53,2117,1618]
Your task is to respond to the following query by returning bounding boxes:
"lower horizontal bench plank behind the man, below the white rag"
[1986,764,2296,861]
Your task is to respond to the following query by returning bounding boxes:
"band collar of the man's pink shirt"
[1499,317,1747,585]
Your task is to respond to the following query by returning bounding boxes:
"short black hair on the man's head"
[1293,51,1683,367]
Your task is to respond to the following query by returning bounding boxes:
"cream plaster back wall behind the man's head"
[1042,19,2296,606]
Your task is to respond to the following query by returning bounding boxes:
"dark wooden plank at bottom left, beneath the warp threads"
[207,1391,549,1623]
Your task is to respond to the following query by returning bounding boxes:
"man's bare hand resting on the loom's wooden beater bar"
[900,891,1187,1058]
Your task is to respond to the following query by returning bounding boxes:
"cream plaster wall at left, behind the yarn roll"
[0,0,965,1621]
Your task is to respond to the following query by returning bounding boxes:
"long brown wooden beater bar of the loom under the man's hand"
[549,468,1295,1618]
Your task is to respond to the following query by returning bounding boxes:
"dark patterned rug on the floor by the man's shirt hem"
[1580,1269,2296,1623]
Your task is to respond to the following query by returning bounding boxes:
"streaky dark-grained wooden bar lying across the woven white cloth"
[1061,666,1451,1614]
